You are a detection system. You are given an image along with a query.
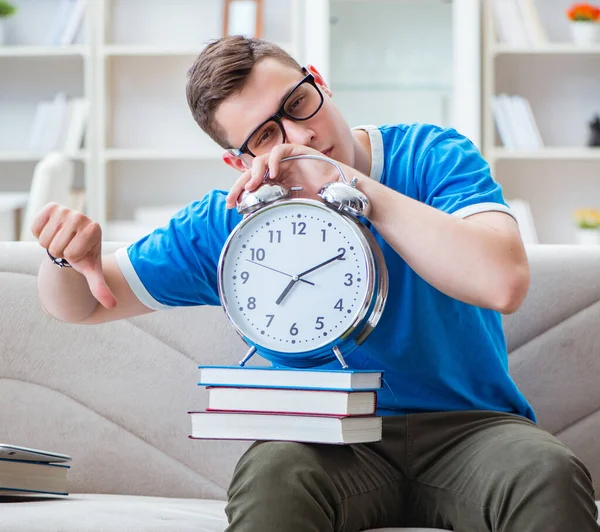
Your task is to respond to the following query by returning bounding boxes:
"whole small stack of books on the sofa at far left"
[0,444,71,495]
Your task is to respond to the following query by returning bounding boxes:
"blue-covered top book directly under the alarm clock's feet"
[198,366,382,391]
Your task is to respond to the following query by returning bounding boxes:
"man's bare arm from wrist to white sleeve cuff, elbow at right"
[354,177,529,314]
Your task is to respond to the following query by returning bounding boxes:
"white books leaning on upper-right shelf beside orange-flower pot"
[491,0,548,47]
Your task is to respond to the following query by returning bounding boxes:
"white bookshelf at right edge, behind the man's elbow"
[482,0,600,244]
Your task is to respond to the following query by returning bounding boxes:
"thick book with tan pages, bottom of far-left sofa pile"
[0,458,69,495]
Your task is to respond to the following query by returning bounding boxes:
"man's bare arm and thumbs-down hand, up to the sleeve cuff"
[31,204,152,324]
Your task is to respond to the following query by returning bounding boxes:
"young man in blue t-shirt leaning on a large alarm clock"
[33,37,599,532]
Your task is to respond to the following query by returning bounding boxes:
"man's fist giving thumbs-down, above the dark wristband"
[31,203,117,308]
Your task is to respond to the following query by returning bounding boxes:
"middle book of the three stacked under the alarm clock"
[206,386,377,416]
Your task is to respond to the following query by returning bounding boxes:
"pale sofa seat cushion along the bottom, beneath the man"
[0,493,446,532]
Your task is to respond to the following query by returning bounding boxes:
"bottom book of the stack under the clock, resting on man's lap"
[189,411,382,444]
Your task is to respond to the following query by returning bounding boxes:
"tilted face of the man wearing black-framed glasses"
[215,59,354,170]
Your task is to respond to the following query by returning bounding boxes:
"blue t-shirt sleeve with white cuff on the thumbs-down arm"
[116,191,241,310]
